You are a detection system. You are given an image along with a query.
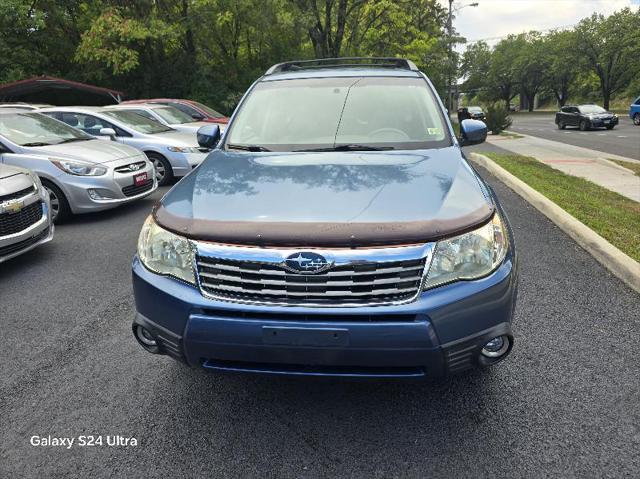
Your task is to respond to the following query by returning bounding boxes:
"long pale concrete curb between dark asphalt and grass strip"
[468,153,640,293]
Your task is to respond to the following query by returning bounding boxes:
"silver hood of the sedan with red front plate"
[27,140,141,164]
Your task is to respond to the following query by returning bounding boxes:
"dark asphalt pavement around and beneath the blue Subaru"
[0,162,640,478]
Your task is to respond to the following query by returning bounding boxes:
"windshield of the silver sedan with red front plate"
[0,113,94,146]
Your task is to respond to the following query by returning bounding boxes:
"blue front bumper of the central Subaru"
[133,248,517,377]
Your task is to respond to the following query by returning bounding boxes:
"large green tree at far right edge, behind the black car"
[575,8,640,110]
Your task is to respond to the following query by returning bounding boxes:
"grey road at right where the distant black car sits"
[510,113,640,160]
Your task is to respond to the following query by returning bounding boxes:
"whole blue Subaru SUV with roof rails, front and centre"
[133,58,517,378]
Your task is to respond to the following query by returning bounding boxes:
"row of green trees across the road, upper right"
[461,8,640,110]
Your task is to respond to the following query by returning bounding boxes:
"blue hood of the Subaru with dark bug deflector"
[154,147,494,246]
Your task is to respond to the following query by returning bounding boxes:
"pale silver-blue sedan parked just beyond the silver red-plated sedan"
[39,106,210,185]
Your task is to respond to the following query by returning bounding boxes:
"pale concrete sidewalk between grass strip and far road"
[487,133,640,202]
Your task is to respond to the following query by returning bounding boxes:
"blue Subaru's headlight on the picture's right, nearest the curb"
[423,213,507,289]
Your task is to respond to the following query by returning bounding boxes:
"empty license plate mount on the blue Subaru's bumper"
[262,326,349,347]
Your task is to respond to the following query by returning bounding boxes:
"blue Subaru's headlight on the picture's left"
[138,216,196,284]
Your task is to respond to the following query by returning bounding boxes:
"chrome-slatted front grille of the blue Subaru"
[197,255,426,306]
